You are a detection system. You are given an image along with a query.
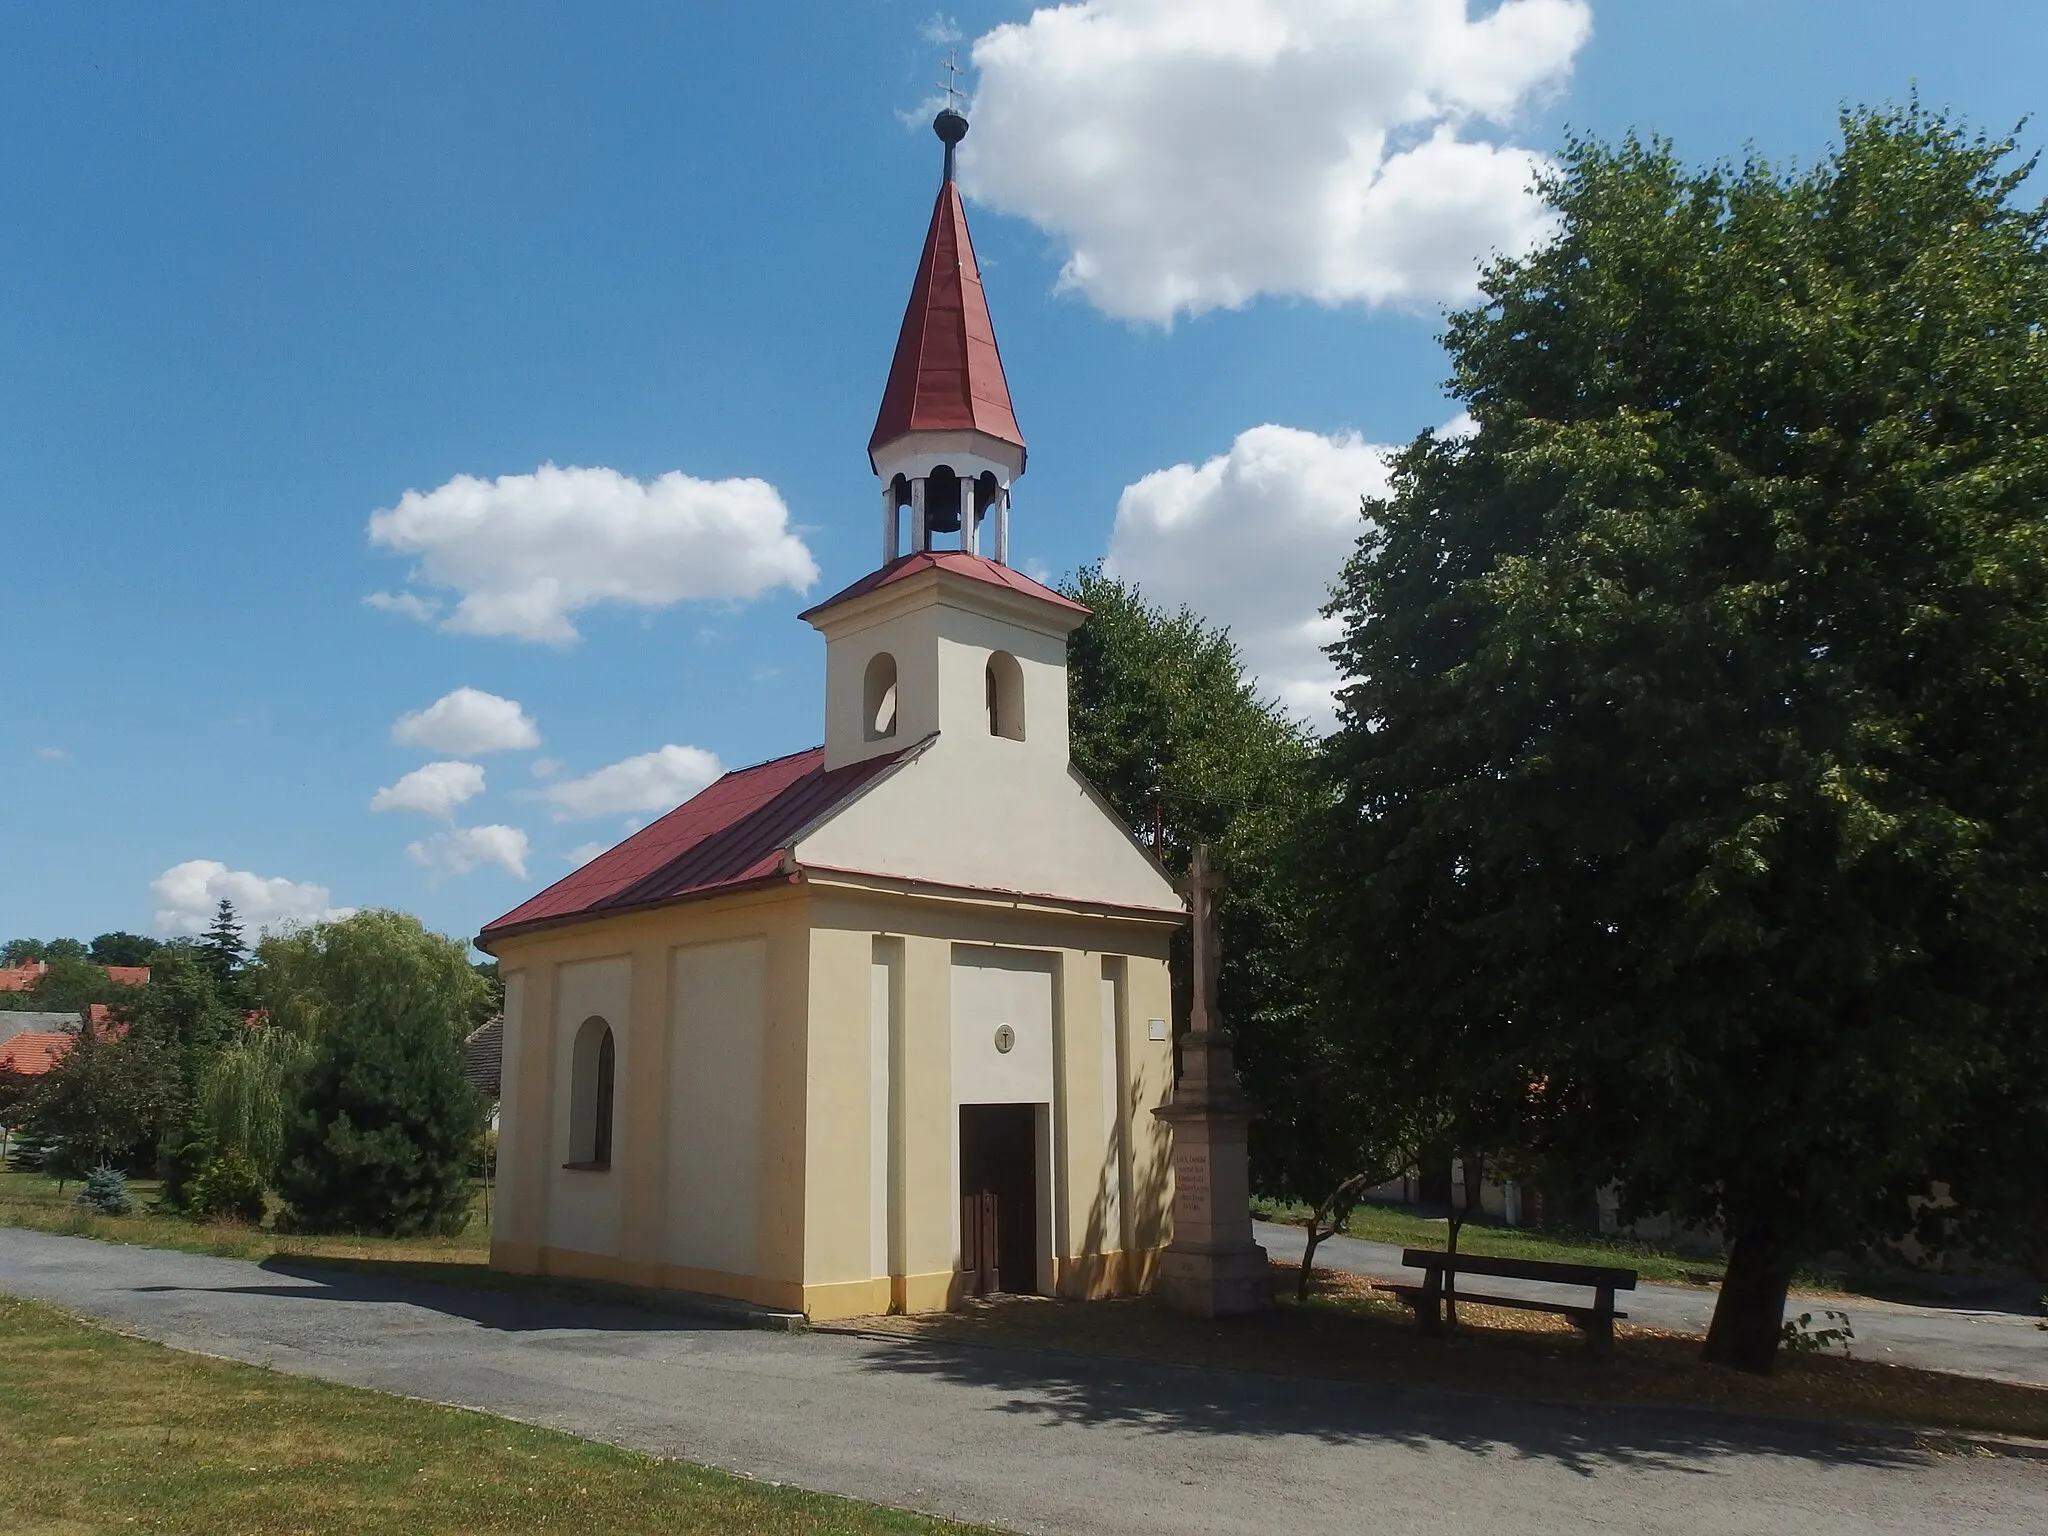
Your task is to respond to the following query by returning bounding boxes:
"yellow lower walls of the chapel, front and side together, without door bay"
[492,887,1171,1319]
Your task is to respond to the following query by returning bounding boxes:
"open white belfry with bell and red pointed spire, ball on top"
[868,106,1024,565]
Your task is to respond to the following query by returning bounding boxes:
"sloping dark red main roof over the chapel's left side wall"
[477,743,922,940]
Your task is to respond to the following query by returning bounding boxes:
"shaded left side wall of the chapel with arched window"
[492,887,809,1309]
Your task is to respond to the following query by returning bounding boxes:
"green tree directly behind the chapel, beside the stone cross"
[1063,567,1386,1202]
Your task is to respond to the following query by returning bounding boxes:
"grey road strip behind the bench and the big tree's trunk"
[1253,1221,2048,1386]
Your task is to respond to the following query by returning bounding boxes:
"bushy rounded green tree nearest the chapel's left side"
[258,911,485,1237]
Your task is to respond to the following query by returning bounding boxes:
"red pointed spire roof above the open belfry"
[868,178,1024,463]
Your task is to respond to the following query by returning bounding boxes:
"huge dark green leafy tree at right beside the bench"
[1327,104,2048,1370]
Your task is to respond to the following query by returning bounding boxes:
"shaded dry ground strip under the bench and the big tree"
[819,1264,2048,1440]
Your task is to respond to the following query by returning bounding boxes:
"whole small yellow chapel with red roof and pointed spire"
[477,109,1186,1319]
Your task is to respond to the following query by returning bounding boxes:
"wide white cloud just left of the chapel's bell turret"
[371,465,817,643]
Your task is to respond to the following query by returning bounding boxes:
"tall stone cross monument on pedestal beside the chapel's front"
[1153,844,1274,1317]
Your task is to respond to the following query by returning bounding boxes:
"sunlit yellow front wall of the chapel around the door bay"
[803,891,1174,1317]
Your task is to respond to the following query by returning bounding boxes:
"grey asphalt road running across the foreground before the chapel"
[0,1229,2048,1536]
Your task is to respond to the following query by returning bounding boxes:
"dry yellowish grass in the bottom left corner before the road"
[0,1300,991,1536]
